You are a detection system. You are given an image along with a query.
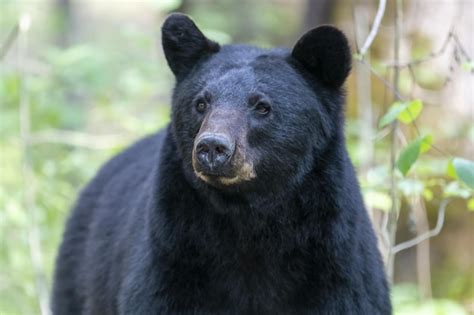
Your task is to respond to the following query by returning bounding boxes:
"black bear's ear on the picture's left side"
[161,13,219,80]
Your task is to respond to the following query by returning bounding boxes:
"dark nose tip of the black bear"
[196,134,234,175]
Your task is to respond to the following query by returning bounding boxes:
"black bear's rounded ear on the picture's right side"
[291,25,351,88]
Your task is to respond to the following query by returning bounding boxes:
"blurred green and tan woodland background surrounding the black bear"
[0,0,474,315]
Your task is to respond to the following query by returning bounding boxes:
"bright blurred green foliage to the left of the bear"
[0,2,172,314]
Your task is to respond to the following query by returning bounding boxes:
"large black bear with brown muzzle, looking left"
[52,14,391,315]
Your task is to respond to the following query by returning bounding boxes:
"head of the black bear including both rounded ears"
[162,14,350,198]
